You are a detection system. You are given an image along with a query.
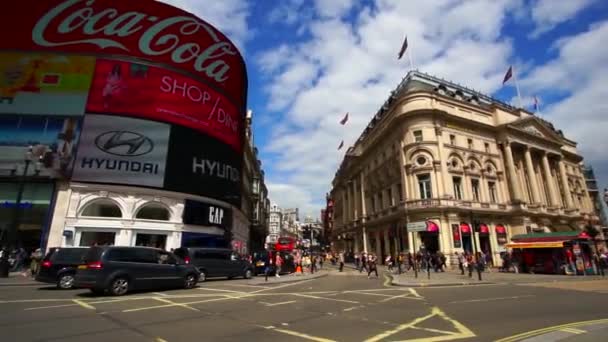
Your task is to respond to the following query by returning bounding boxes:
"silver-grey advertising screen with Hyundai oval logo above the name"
[72,114,170,187]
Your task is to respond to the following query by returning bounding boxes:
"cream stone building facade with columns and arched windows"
[328,72,599,263]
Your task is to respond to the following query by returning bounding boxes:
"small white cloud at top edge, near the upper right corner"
[529,0,594,38]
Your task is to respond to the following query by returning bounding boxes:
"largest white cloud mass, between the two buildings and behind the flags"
[257,0,521,214]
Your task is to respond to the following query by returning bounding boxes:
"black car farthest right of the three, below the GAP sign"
[174,247,253,281]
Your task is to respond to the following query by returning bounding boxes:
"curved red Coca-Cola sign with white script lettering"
[0,0,247,109]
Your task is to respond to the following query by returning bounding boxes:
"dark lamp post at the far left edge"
[0,146,38,278]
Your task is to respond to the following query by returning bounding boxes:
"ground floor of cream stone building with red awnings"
[332,208,580,266]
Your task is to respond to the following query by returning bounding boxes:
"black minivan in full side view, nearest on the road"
[74,246,199,296]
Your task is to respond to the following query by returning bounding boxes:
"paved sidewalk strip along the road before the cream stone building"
[392,270,608,287]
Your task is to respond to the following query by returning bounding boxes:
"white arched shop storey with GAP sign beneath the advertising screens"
[39,183,249,254]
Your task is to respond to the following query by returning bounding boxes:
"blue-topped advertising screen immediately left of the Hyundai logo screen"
[0,115,81,178]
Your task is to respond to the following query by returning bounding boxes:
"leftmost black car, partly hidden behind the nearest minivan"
[36,247,88,289]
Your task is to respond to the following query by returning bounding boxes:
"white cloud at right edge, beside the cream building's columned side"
[521,21,608,184]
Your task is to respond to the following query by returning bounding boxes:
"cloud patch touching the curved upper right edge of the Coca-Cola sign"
[161,0,252,48]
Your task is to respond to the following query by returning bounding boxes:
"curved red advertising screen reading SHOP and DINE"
[86,59,242,152]
